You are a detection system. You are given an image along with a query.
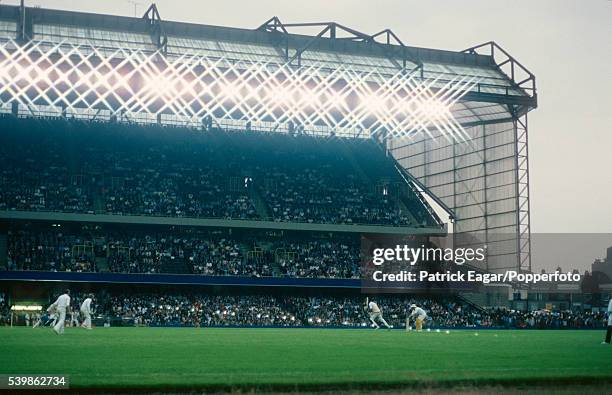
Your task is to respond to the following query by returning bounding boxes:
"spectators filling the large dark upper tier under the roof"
[0,117,440,226]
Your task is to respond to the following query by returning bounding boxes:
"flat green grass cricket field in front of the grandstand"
[0,328,612,390]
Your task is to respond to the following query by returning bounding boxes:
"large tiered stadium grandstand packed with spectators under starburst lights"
[0,5,540,327]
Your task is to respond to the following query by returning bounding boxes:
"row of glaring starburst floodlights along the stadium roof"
[0,41,477,140]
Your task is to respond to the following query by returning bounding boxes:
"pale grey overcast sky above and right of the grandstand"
[0,0,612,268]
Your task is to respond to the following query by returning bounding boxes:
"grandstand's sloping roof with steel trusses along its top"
[0,5,537,138]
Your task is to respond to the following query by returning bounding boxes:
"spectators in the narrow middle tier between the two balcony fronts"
[7,224,360,278]
